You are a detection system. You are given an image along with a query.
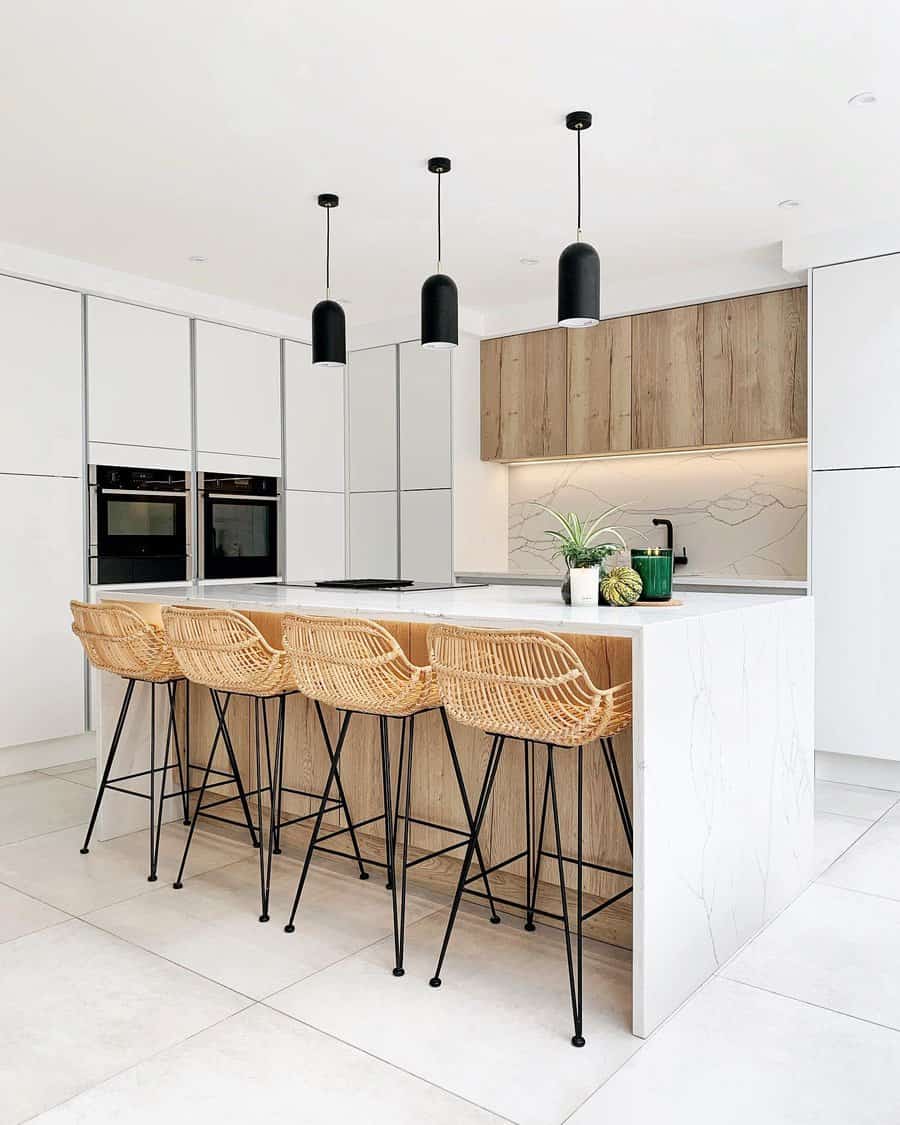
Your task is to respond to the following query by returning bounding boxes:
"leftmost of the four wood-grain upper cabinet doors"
[482,329,566,460]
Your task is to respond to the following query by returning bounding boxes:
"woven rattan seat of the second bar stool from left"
[162,605,297,695]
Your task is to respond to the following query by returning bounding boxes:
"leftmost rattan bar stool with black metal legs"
[70,601,190,883]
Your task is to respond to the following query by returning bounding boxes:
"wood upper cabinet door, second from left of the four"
[566,316,631,453]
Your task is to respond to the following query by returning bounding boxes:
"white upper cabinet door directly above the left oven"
[88,297,191,450]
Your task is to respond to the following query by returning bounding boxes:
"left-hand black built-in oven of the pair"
[90,465,191,585]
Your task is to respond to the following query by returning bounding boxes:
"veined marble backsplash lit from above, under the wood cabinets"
[510,446,807,578]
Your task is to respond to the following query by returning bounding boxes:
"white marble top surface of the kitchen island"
[105,583,797,637]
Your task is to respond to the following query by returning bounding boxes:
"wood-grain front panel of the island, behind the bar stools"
[181,612,631,948]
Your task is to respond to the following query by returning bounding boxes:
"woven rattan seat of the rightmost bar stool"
[429,624,631,746]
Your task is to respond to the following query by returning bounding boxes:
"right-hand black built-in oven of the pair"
[198,473,279,579]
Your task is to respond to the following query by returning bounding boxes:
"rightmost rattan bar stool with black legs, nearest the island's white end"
[429,624,633,1047]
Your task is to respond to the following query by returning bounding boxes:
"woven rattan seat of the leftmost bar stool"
[70,601,182,683]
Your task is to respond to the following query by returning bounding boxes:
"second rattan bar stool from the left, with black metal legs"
[162,606,362,923]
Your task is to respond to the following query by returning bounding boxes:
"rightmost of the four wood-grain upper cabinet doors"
[703,287,807,446]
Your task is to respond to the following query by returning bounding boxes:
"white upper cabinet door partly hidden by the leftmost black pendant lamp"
[285,340,344,493]
